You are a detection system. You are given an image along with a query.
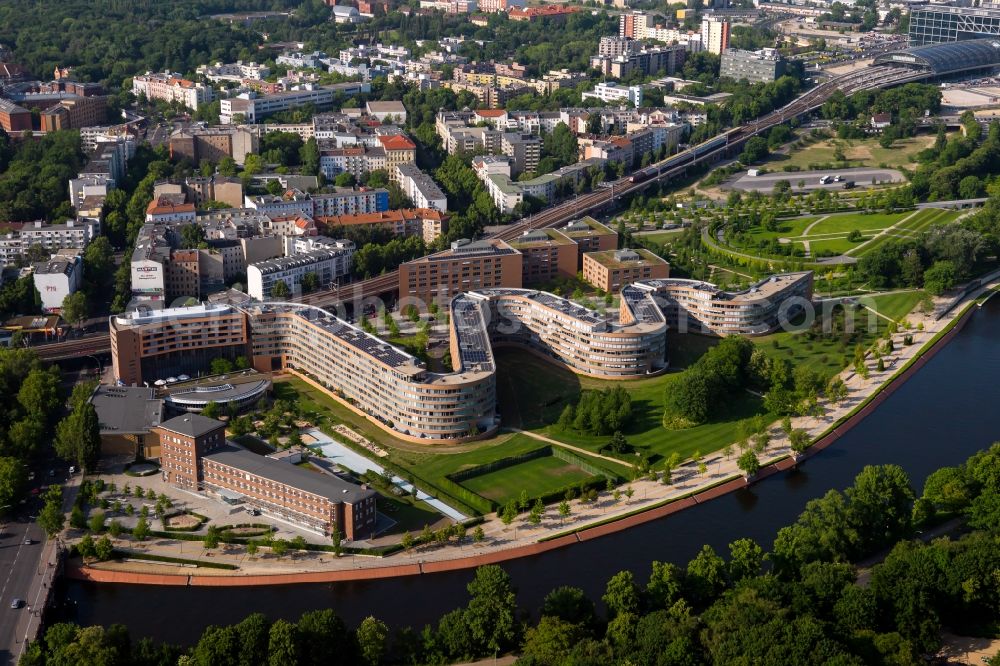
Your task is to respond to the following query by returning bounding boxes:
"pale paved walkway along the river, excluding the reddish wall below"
[68,281,1000,577]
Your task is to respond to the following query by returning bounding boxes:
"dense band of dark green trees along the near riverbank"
[22,444,1000,666]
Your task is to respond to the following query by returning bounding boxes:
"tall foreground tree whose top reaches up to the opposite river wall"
[465,564,517,654]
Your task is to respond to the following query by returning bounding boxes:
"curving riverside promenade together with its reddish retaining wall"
[67,280,1000,585]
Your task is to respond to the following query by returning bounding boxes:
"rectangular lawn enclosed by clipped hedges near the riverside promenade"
[461,455,591,505]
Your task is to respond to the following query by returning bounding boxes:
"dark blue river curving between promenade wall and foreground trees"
[52,299,1000,643]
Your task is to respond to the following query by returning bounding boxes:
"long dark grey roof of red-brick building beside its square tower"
[204,445,375,504]
